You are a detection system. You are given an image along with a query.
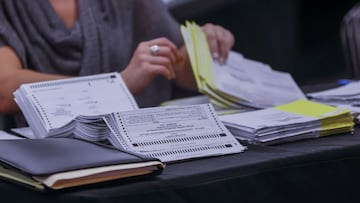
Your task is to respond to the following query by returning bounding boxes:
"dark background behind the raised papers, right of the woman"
[170,0,357,85]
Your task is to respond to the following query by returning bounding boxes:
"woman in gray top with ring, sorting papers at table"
[0,0,234,126]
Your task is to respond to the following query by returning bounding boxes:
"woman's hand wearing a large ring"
[121,38,179,94]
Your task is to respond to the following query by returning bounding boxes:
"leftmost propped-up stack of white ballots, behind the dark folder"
[14,73,138,141]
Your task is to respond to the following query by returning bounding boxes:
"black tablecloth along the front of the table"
[0,128,360,203]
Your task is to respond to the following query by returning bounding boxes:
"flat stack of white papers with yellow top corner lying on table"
[220,100,354,145]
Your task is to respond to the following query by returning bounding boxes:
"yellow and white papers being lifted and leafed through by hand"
[181,22,305,108]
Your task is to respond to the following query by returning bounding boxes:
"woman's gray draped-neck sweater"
[0,0,182,107]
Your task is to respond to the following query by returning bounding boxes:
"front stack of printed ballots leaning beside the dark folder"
[104,104,245,162]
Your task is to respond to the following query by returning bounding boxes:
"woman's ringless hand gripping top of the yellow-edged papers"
[202,23,235,64]
